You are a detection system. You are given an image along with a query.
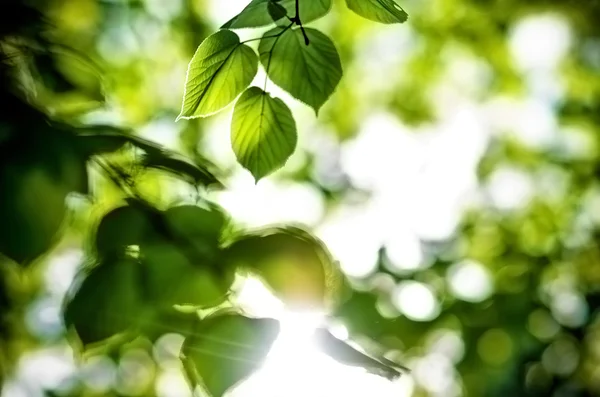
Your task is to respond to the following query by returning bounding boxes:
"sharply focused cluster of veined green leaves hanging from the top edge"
[178,0,407,182]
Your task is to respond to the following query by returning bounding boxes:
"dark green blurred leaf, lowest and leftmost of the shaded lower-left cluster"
[64,258,145,346]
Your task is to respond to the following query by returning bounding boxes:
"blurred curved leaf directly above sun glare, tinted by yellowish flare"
[225,227,342,308]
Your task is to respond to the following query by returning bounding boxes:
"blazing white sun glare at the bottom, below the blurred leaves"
[229,279,413,397]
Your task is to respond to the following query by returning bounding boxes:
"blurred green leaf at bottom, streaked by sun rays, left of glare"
[182,313,279,397]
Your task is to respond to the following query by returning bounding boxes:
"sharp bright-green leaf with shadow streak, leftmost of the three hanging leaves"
[177,30,258,119]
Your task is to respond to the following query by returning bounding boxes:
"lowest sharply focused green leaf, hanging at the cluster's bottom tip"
[231,87,298,182]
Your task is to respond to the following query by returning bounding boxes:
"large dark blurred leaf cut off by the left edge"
[0,121,88,264]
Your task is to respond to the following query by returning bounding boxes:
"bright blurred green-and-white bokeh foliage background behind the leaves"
[2,0,600,397]
